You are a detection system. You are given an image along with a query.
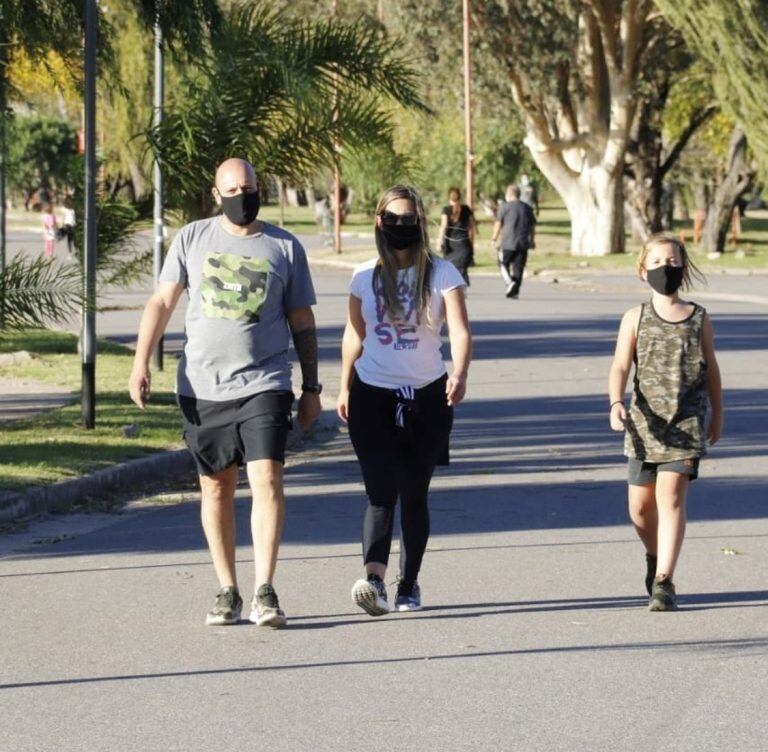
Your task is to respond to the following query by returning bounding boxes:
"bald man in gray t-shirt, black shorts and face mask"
[129,159,322,627]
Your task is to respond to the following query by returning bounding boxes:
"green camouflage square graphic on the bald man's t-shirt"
[200,251,269,322]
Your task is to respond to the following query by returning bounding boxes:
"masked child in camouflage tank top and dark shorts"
[608,234,723,611]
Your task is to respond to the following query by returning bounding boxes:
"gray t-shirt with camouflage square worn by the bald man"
[160,217,315,402]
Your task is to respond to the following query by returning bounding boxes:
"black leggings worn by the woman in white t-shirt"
[349,374,453,582]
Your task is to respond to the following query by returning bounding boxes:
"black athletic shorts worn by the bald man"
[177,392,293,475]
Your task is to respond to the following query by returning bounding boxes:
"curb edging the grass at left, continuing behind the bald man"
[0,410,337,524]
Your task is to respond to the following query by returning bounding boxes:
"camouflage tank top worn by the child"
[624,302,707,462]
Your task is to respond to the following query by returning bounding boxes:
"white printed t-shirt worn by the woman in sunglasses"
[349,257,466,389]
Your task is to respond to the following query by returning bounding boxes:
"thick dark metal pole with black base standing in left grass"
[80,0,98,428]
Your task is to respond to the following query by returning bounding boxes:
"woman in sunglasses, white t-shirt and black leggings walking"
[336,186,472,616]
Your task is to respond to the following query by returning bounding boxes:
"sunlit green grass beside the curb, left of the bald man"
[0,330,181,489]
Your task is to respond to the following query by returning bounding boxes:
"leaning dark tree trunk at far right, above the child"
[701,126,756,254]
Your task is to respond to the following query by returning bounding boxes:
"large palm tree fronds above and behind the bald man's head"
[146,0,424,219]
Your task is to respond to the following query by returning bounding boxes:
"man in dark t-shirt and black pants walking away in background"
[491,183,536,298]
